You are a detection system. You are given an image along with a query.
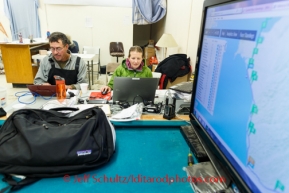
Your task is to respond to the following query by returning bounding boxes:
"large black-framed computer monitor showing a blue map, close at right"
[190,0,289,192]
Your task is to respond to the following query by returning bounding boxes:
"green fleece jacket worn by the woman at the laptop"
[107,59,153,89]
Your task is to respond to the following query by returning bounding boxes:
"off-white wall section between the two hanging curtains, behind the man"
[39,0,133,65]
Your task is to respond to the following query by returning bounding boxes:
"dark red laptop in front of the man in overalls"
[26,84,56,97]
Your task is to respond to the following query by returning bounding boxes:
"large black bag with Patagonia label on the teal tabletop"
[0,107,115,192]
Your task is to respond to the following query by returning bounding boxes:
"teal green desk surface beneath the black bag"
[0,126,193,193]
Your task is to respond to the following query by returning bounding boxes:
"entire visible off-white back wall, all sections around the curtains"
[0,0,204,70]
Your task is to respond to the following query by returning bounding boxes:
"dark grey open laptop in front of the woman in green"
[112,77,159,104]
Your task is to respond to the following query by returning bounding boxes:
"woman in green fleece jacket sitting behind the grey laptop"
[100,46,153,92]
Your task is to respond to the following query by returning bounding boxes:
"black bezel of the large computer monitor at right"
[189,0,252,192]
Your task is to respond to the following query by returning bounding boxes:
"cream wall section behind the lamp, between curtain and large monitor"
[153,0,204,71]
